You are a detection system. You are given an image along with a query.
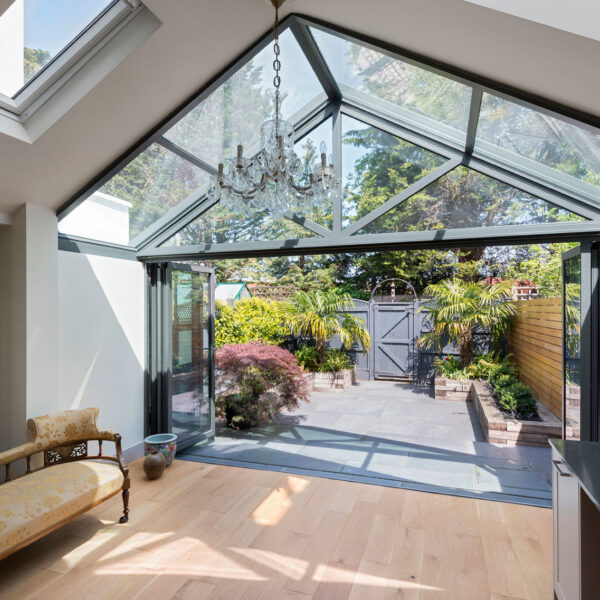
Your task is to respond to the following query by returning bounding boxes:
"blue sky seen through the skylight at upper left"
[25,0,112,56]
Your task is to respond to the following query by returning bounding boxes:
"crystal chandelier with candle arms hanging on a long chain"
[209,0,339,218]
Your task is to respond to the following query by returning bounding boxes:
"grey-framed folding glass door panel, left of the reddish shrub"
[166,264,215,448]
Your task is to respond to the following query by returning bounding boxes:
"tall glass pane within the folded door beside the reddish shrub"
[171,270,212,443]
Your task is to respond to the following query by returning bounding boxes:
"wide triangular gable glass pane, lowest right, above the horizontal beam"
[358,167,584,234]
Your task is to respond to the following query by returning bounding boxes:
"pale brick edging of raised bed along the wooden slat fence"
[470,381,562,447]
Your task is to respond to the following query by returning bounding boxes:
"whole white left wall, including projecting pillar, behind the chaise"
[0,204,145,458]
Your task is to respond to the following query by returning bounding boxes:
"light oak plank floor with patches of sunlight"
[0,461,552,600]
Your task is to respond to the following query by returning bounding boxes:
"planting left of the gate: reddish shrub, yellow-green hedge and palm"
[215,290,370,429]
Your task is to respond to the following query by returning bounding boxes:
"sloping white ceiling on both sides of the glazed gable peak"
[0,0,600,213]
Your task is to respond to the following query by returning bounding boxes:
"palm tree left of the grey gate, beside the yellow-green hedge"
[290,290,371,363]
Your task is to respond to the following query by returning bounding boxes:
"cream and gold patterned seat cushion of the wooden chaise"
[0,460,123,556]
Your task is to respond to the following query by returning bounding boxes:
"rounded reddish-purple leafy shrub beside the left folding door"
[216,342,308,428]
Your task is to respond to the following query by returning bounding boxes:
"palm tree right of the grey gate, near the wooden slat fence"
[417,277,516,367]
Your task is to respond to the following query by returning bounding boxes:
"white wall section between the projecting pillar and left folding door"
[56,251,145,448]
